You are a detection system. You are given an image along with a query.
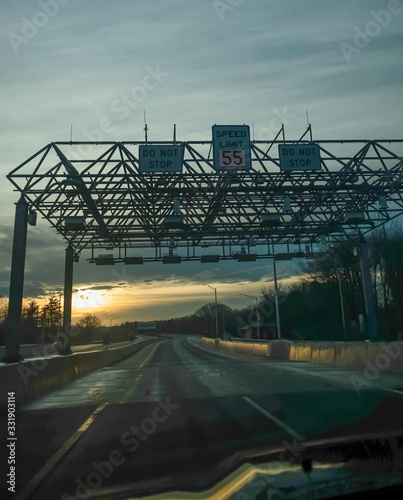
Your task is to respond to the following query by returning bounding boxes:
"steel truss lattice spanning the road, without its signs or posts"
[7,136,403,263]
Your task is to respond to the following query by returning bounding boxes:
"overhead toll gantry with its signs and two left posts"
[5,125,403,360]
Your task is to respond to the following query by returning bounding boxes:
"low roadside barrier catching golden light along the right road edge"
[202,337,403,374]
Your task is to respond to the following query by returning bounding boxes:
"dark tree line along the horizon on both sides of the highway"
[0,225,403,343]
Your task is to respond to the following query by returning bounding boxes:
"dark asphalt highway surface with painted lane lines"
[2,336,403,500]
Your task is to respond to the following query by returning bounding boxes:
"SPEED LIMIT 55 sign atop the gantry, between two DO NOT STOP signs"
[213,125,252,170]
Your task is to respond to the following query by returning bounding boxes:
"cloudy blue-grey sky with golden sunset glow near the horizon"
[0,0,403,323]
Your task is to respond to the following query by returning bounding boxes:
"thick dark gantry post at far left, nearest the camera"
[3,195,28,363]
